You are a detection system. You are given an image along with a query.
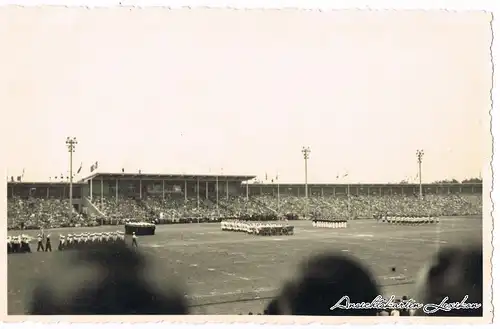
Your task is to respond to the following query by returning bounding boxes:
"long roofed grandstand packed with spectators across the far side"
[7,173,482,229]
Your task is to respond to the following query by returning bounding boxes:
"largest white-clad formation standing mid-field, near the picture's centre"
[220,220,294,235]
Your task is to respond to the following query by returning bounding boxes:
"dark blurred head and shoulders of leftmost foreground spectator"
[30,246,188,315]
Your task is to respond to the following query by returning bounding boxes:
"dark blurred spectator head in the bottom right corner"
[417,246,483,317]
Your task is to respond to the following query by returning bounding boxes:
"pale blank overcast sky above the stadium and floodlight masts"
[0,8,491,183]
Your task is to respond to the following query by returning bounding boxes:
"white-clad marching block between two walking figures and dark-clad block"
[57,231,127,251]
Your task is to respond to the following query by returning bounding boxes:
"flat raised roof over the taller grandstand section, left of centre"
[80,173,256,183]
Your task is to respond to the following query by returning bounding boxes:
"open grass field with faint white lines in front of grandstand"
[8,217,482,314]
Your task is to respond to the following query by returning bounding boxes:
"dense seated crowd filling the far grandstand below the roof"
[8,194,482,229]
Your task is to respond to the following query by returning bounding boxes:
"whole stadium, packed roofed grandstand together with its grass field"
[7,172,482,314]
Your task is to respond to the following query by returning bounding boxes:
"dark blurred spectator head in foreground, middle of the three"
[277,254,379,316]
